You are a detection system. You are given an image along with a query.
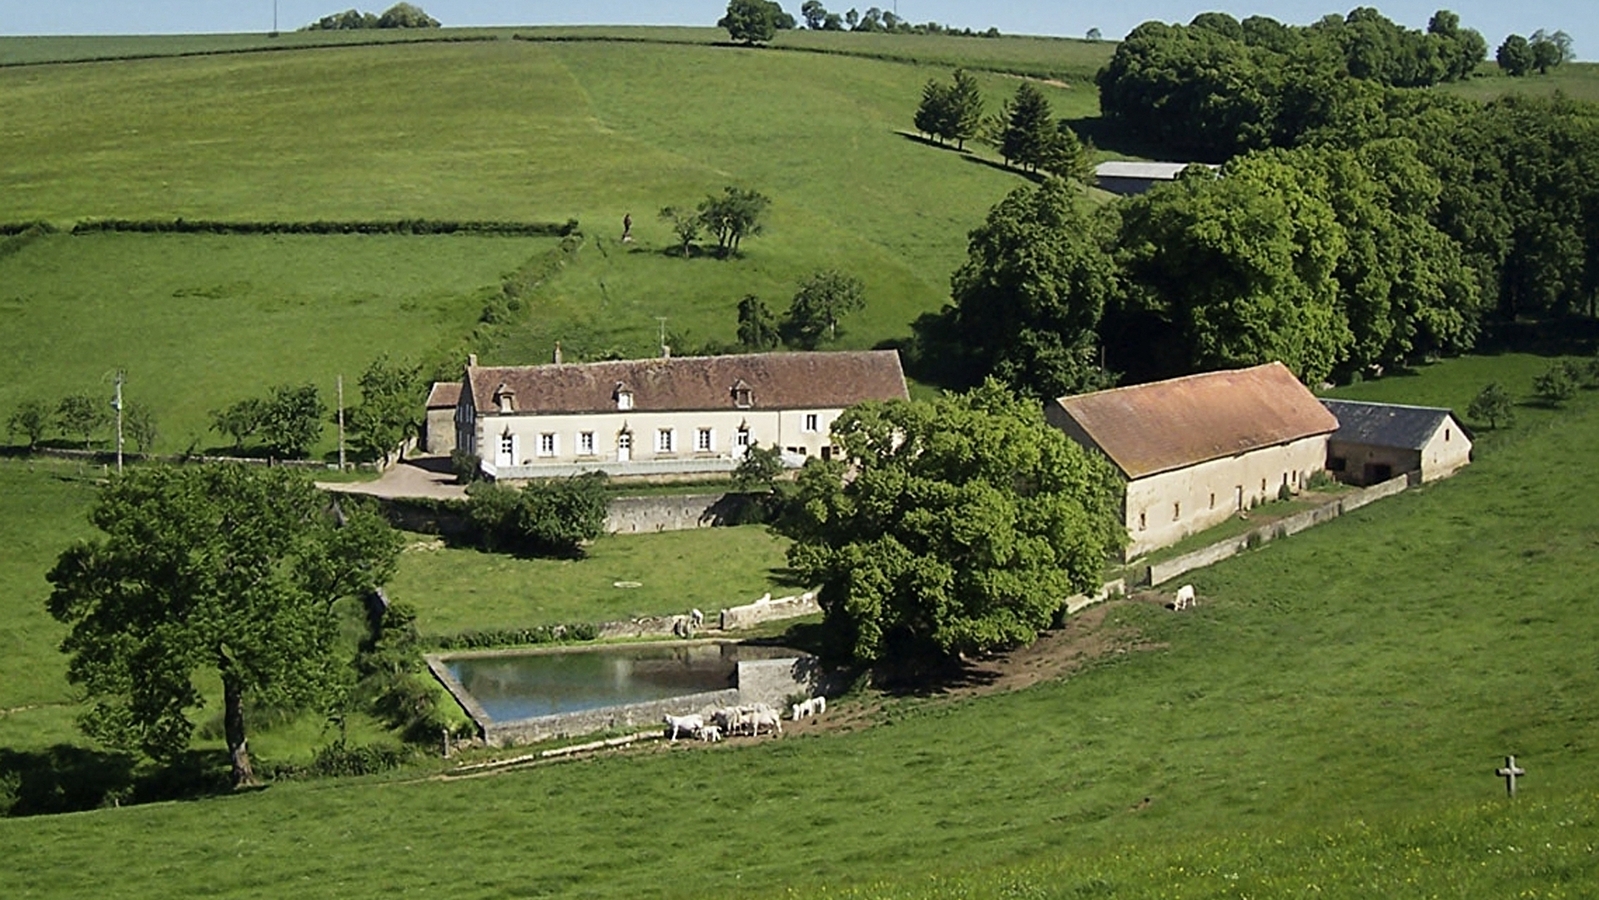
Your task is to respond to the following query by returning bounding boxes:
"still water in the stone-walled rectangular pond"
[443,644,793,723]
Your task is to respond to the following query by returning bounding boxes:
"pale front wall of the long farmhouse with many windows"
[457,409,843,478]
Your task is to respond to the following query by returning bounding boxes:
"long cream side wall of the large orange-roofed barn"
[1124,435,1327,560]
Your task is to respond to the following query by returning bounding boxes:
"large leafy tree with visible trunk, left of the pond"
[48,465,400,787]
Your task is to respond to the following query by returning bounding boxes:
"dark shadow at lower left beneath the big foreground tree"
[0,743,232,817]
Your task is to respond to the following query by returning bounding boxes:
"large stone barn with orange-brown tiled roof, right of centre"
[1044,363,1338,558]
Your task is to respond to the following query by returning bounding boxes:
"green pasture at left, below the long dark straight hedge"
[0,235,555,452]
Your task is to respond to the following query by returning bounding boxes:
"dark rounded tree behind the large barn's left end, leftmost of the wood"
[945,177,1116,398]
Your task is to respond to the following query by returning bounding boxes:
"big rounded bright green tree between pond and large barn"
[777,384,1126,663]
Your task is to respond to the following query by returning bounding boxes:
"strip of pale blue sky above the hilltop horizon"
[0,0,1599,59]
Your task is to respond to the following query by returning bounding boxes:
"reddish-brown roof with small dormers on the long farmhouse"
[465,350,910,414]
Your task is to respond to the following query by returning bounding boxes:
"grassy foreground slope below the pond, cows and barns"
[0,358,1599,897]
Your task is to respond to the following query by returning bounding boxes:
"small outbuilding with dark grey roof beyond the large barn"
[1322,400,1471,484]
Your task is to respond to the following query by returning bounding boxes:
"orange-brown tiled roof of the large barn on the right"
[1055,363,1338,478]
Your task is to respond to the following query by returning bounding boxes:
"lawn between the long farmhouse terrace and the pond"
[389,526,798,635]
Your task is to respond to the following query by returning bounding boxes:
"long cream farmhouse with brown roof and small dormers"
[456,350,908,480]
